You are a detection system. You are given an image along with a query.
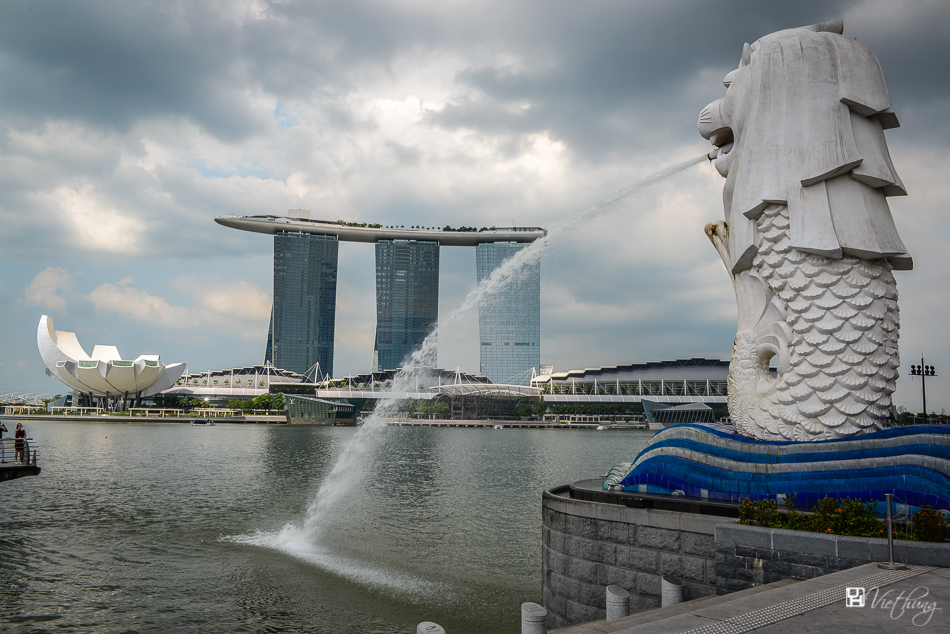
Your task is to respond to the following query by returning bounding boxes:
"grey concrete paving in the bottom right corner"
[550,564,950,634]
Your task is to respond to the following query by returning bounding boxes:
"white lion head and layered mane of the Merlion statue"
[699,20,911,274]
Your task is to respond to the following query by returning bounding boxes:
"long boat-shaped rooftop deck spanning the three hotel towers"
[214,215,547,242]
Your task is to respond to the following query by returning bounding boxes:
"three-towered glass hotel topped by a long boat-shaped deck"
[215,209,547,384]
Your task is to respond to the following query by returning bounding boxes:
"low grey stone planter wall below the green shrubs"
[715,523,950,594]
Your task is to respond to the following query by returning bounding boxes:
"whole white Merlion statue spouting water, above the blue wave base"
[699,21,913,441]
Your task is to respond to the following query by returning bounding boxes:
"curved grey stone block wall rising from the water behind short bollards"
[542,486,723,628]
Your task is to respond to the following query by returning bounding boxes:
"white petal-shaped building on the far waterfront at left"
[36,315,185,396]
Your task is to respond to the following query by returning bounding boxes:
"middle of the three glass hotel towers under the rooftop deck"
[373,240,439,372]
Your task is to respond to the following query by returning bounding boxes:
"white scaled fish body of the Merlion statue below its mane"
[728,205,900,441]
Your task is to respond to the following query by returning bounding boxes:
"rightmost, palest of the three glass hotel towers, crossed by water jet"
[475,242,541,385]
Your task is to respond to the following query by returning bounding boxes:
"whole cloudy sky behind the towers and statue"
[0,0,950,411]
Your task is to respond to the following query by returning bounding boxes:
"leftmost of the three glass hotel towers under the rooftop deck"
[264,232,339,376]
